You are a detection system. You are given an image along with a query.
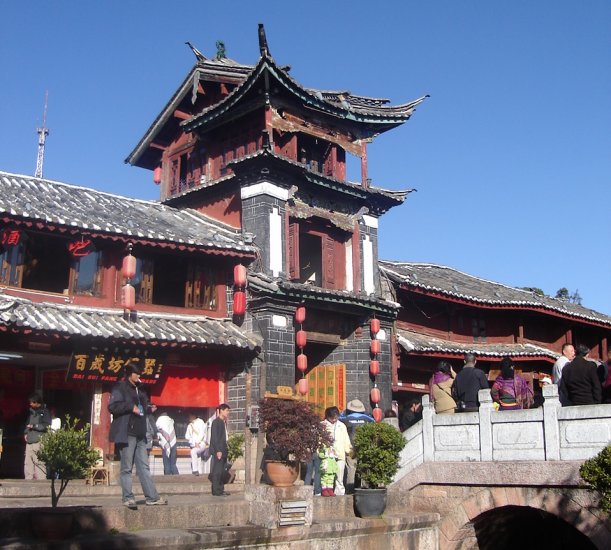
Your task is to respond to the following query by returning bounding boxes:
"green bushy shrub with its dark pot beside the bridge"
[354,422,406,517]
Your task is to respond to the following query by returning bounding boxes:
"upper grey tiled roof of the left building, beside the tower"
[0,172,254,254]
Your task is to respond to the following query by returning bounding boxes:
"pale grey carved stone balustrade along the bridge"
[395,384,611,481]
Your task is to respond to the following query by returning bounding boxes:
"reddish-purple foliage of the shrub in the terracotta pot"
[259,398,331,462]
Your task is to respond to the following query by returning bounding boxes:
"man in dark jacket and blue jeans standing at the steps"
[108,363,168,509]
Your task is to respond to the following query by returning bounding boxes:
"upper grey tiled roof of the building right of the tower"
[380,260,611,326]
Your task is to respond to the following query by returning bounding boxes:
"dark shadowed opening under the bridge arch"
[473,506,596,550]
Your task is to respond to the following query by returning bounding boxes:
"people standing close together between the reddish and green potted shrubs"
[305,399,374,497]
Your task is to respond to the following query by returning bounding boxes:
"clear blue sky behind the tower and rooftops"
[0,0,611,314]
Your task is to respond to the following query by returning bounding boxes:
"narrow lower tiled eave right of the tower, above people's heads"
[397,329,558,360]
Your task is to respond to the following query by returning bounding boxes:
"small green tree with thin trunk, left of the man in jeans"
[36,416,99,508]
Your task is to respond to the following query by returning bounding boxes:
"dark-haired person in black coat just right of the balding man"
[559,344,602,406]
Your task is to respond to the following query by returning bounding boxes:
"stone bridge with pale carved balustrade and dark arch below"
[389,385,611,550]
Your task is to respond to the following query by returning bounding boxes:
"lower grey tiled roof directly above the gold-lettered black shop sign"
[0,295,258,351]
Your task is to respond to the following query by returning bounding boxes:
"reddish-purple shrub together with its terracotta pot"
[259,398,331,487]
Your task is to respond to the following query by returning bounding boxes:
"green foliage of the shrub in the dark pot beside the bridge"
[354,422,406,489]
